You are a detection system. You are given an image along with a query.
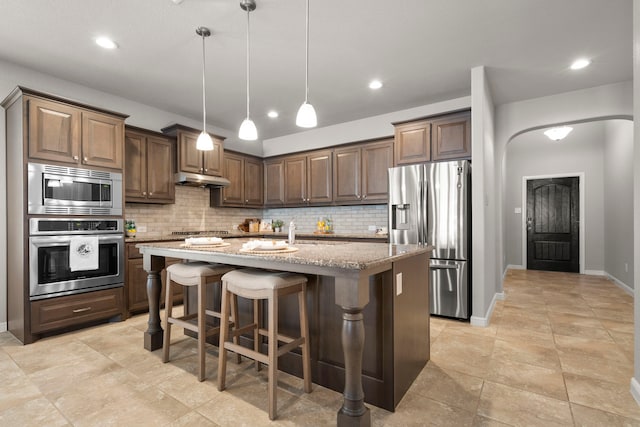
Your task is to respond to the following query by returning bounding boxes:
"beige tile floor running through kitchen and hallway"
[0,270,640,427]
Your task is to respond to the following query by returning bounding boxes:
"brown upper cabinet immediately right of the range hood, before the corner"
[211,151,264,208]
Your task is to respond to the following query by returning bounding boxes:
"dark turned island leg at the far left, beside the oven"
[142,254,164,351]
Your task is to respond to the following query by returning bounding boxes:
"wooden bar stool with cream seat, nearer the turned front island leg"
[218,268,311,420]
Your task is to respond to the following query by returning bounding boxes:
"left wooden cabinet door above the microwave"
[26,98,81,164]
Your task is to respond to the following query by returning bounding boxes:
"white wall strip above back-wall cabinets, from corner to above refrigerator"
[263,96,471,157]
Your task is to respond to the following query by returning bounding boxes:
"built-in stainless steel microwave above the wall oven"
[27,163,122,215]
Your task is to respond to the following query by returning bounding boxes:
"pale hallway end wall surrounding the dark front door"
[503,121,605,272]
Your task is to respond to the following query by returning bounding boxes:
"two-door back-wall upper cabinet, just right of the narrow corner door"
[284,150,333,206]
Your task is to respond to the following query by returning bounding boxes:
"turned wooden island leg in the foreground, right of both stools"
[335,274,371,427]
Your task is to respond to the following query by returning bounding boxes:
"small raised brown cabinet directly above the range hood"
[162,125,224,176]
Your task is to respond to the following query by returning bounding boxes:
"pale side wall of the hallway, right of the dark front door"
[603,120,634,289]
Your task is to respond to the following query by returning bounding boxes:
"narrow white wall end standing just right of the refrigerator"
[471,67,502,326]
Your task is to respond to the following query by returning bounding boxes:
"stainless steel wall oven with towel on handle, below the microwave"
[29,217,124,300]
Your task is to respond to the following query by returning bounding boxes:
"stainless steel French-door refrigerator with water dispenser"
[389,160,471,319]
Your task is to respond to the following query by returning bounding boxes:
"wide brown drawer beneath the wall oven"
[31,287,124,333]
